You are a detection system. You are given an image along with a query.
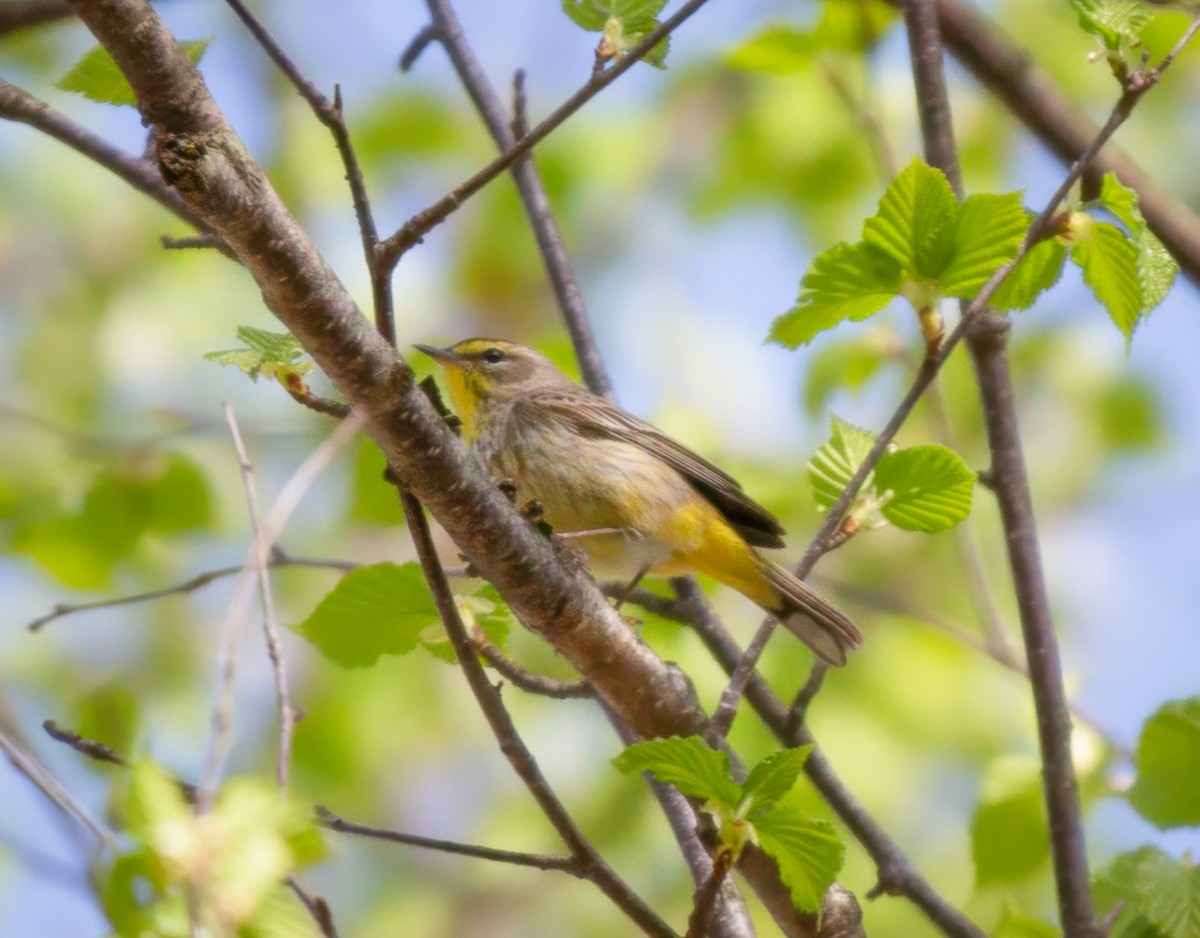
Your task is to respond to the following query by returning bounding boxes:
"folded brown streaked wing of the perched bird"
[523,389,784,547]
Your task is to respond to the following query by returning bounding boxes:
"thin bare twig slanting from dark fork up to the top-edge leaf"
[378,0,708,269]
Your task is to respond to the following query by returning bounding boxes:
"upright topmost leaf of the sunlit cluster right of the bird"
[863,160,959,281]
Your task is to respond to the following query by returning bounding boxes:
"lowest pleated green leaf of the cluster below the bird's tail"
[755,806,845,912]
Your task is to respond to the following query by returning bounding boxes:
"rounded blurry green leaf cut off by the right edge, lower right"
[1129,697,1200,828]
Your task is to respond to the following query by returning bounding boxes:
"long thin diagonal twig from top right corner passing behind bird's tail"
[712,5,1200,736]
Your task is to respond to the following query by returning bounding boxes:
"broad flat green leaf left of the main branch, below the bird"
[295,563,438,668]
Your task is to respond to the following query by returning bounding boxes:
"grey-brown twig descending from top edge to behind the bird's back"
[417,0,612,397]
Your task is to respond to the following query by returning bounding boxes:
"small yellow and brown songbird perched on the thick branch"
[416,338,863,665]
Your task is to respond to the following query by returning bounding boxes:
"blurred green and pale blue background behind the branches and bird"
[0,0,1200,938]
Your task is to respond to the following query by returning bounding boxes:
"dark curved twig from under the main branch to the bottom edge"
[401,493,676,938]
